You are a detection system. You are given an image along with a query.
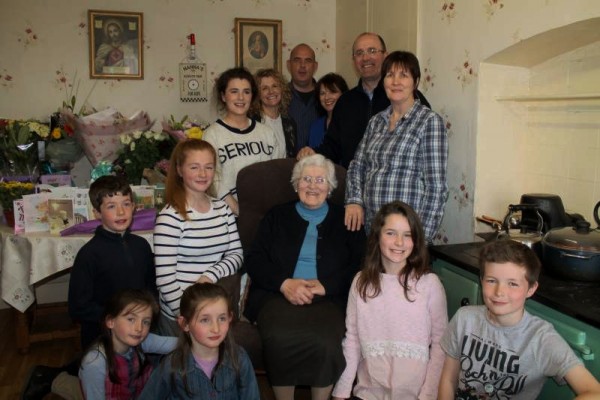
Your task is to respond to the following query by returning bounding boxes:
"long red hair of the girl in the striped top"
[165,139,218,220]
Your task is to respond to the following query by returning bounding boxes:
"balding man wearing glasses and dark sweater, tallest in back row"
[298,32,430,168]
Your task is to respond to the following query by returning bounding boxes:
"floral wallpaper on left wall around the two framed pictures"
[0,0,336,184]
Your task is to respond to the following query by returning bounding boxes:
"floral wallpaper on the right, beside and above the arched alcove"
[418,0,600,243]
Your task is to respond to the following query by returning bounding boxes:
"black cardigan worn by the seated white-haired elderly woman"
[244,201,365,321]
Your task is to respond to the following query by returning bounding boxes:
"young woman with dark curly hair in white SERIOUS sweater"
[202,68,285,215]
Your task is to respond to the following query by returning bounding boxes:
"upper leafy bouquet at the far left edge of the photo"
[0,119,50,176]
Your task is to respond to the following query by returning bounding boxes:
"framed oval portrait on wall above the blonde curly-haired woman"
[235,18,281,73]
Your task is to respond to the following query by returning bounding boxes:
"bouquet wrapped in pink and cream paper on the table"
[62,107,154,166]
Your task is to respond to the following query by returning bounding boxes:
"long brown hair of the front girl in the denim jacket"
[171,283,241,396]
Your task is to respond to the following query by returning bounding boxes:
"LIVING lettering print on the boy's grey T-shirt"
[460,334,527,393]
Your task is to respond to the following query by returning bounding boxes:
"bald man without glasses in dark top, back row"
[287,43,319,151]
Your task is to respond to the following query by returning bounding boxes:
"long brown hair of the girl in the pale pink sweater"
[356,201,430,301]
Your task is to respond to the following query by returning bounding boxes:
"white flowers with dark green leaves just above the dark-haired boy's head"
[113,130,177,185]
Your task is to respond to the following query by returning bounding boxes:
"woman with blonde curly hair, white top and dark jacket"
[250,68,297,157]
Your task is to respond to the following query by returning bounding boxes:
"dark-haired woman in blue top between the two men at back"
[308,72,348,149]
